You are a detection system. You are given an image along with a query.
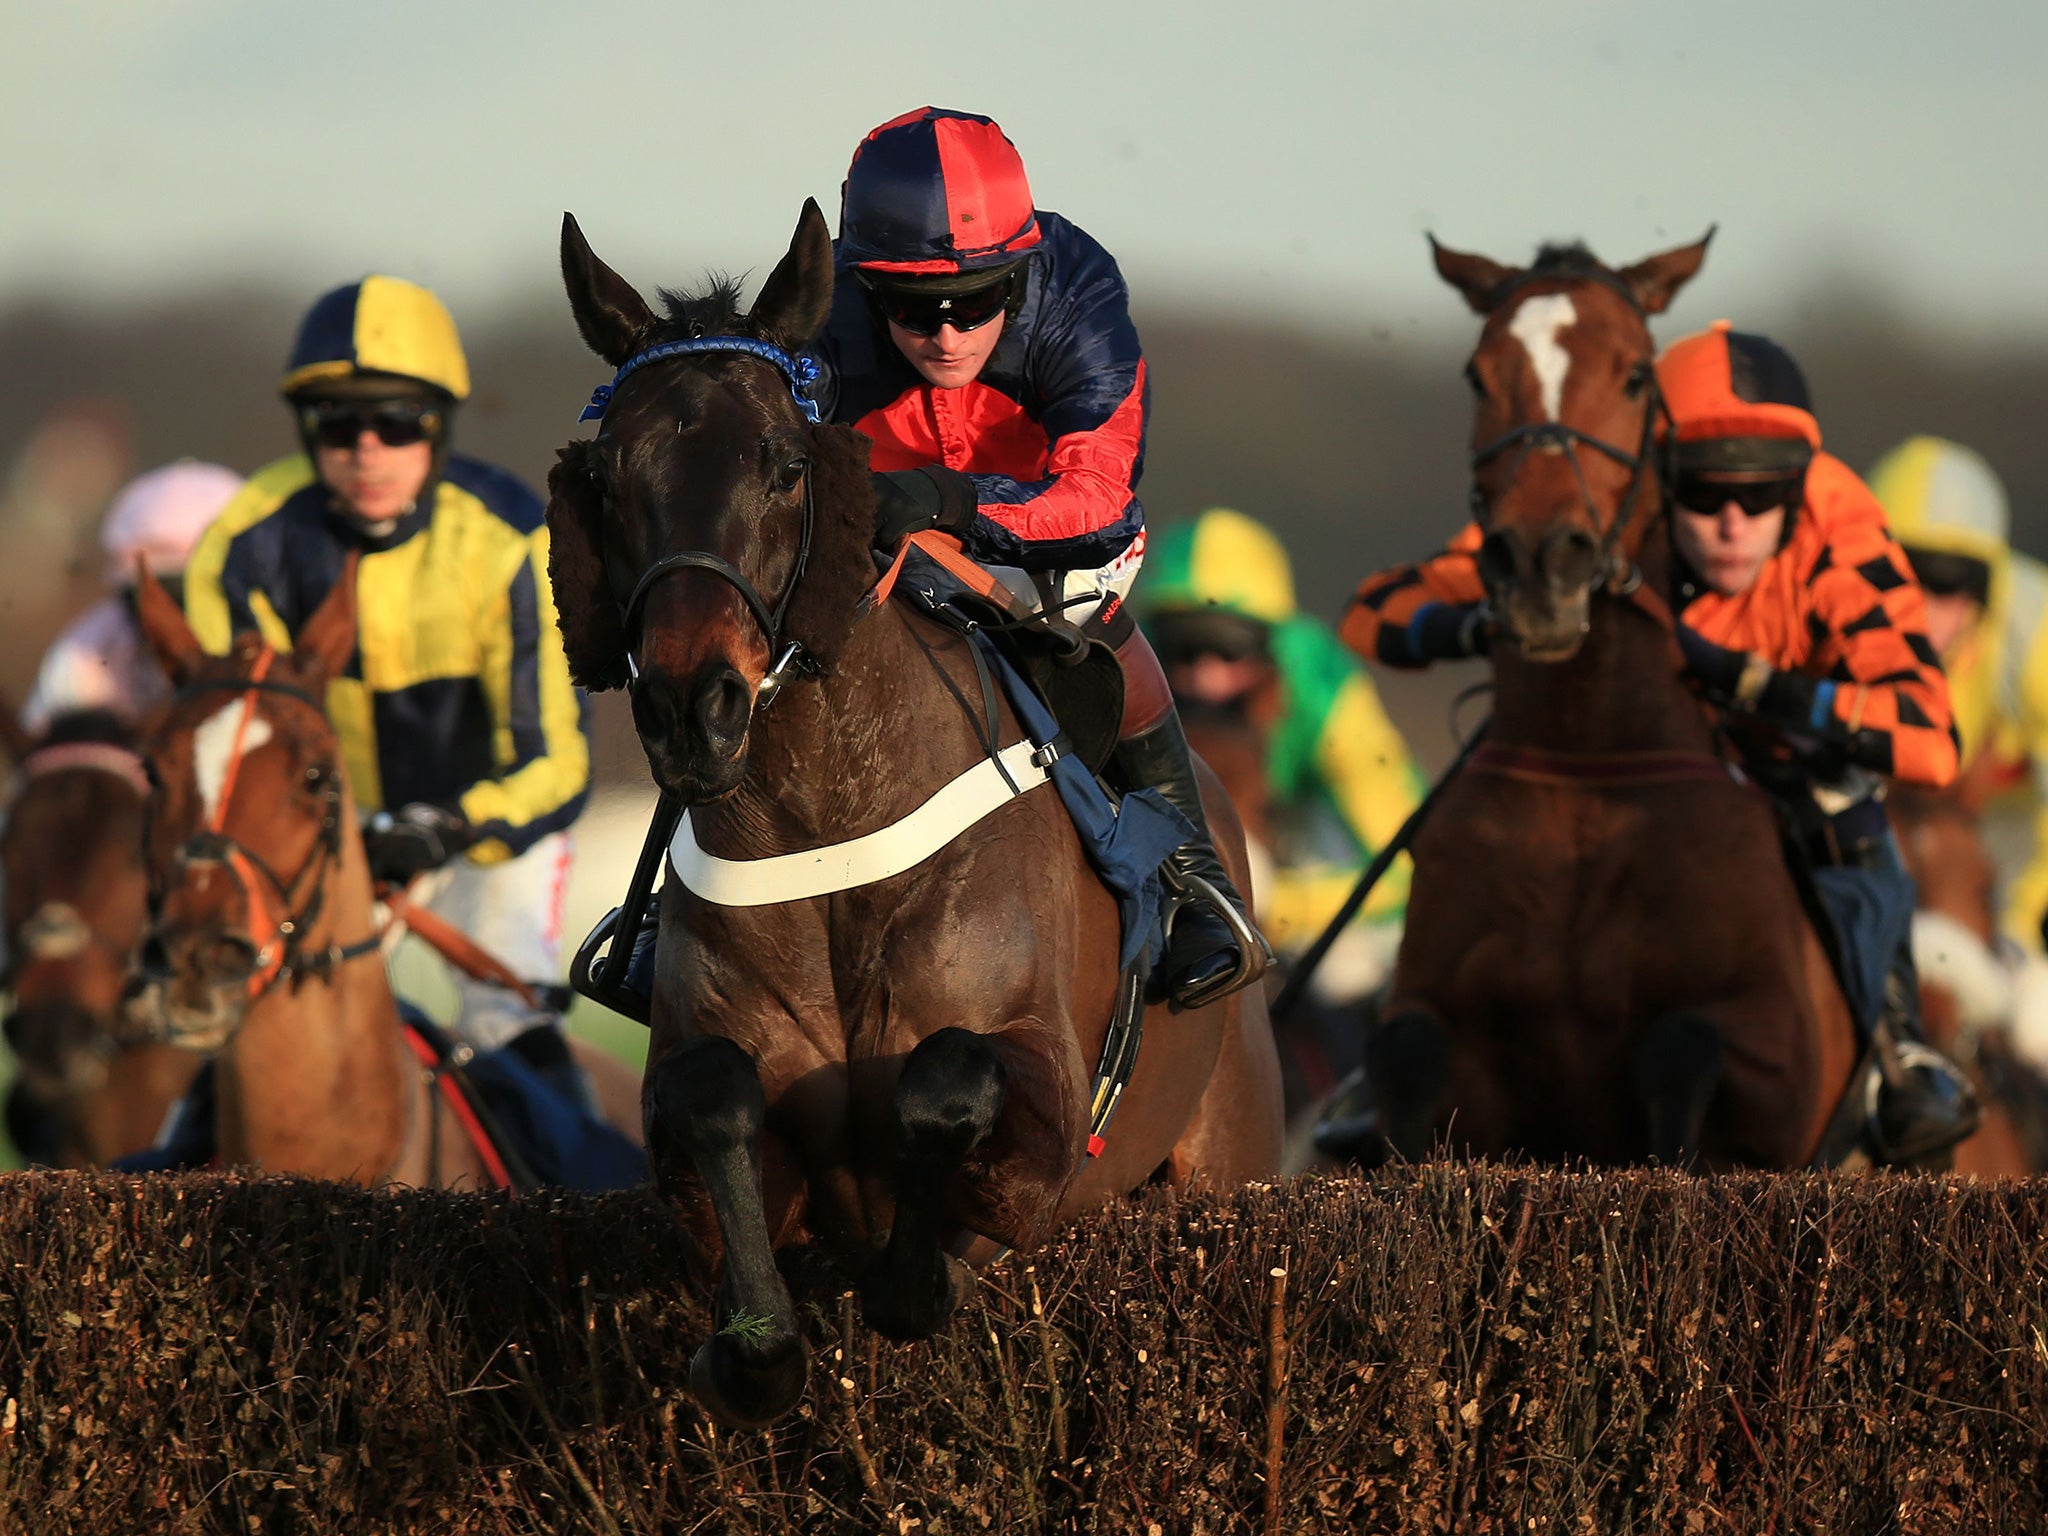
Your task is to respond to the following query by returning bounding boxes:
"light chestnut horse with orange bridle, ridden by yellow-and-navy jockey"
[131,573,637,1188]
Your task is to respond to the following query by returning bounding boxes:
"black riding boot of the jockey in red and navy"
[1112,711,1274,1010]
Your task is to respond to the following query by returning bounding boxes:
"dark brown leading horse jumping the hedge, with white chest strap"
[547,203,1280,1423]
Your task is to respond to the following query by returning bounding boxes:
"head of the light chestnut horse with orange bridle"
[135,557,356,1051]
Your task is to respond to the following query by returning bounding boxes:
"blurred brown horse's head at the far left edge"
[0,713,150,1104]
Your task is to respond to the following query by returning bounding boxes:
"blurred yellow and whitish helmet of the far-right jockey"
[1870,436,2011,600]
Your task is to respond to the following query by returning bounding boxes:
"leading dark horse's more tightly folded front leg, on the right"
[860,1030,1008,1339]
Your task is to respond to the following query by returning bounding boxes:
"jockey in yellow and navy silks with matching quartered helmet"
[184,276,590,1065]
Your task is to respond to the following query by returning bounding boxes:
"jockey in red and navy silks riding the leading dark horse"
[811,106,1272,1008]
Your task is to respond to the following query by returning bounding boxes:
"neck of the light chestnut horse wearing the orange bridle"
[219,803,416,1182]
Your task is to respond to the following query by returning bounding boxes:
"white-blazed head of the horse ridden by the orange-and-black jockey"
[1430,231,1712,662]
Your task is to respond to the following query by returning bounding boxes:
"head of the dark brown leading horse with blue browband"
[547,201,874,805]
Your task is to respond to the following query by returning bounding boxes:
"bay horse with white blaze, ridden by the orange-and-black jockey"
[1368,240,1858,1167]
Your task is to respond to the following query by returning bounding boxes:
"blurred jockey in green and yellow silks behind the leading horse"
[1139,508,1421,952]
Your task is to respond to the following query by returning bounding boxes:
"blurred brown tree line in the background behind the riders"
[0,281,2048,776]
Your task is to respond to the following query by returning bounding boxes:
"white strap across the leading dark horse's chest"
[668,741,1049,907]
